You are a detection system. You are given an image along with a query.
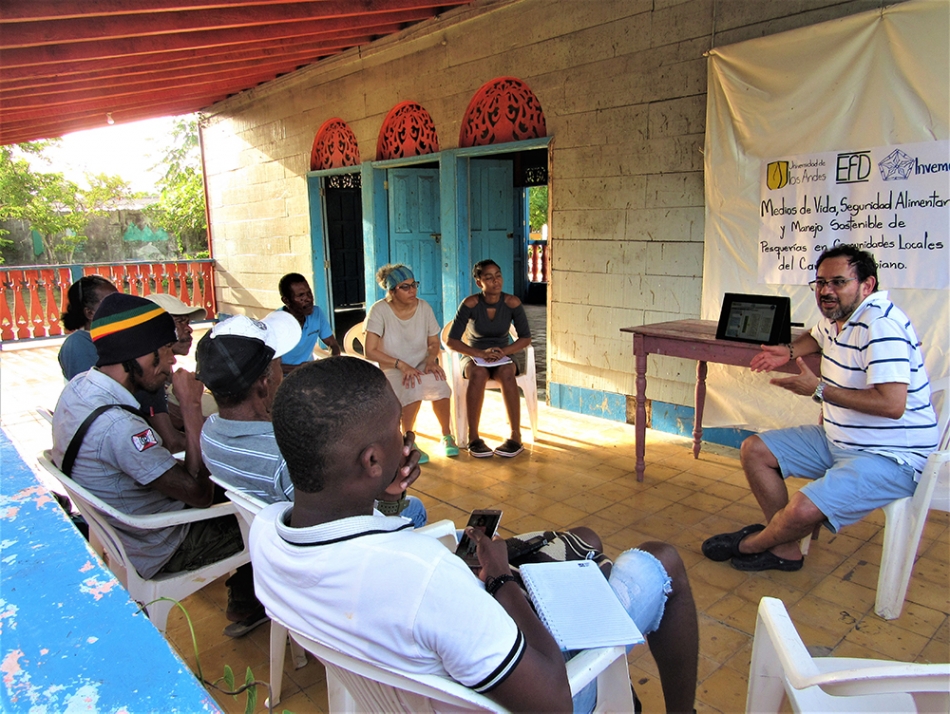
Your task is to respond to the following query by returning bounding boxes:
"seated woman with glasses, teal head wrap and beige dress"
[363,263,459,464]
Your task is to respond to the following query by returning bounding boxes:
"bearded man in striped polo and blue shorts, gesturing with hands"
[703,245,938,571]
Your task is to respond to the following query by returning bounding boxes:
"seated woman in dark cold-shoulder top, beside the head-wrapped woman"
[447,260,531,458]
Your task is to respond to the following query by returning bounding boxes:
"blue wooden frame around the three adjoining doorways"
[307,136,552,330]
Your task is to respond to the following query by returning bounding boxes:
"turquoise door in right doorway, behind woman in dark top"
[469,159,517,294]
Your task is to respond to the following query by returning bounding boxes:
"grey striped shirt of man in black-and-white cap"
[201,414,294,503]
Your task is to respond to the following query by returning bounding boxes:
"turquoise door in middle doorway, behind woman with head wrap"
[388,169,442,325]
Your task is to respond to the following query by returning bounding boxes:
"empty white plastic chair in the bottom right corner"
[745,597,950,714]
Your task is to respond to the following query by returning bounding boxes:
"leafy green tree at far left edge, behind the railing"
[0,141,134,263]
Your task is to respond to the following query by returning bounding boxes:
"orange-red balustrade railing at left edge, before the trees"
[0,260,216,341]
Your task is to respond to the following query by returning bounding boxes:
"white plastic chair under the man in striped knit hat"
[38,451,251,634]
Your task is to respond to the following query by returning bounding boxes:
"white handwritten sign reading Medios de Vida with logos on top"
[758,141,950,289]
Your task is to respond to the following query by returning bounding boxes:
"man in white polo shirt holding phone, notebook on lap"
[250,357,698,712]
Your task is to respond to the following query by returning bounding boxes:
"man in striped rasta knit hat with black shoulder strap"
[53,293,266,637]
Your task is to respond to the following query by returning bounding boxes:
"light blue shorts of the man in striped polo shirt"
[759,424,917,532]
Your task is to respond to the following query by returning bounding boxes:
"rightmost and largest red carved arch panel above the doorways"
[459,77,547,147]
